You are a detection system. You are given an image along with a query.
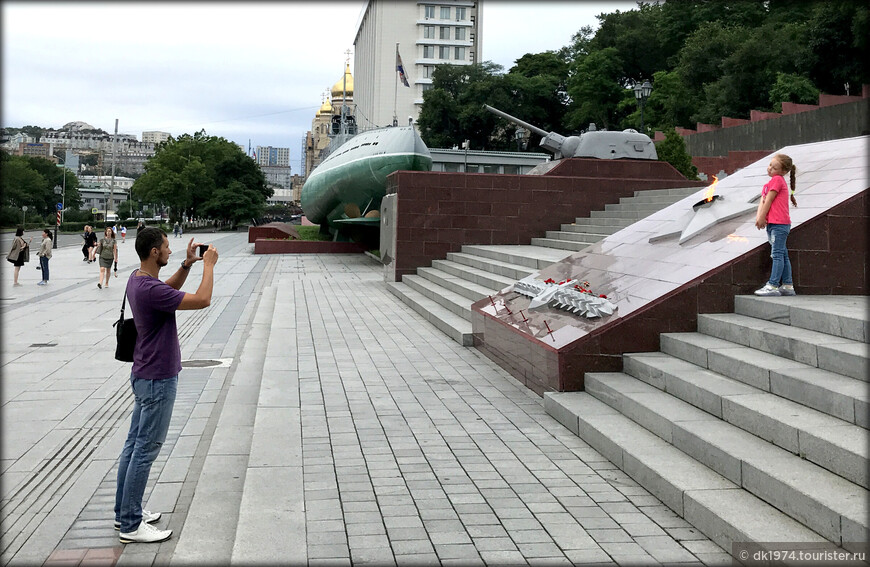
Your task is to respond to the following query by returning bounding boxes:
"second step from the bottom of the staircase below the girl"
[585,373,870,544]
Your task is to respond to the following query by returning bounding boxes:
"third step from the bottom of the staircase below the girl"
[623,352,870,488]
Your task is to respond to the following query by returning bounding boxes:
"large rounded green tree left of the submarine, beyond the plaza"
[133,130,272,222]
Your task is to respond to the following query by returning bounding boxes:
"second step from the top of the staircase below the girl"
[698,313,870,380]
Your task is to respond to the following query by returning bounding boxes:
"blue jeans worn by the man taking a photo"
[115,373,178,533]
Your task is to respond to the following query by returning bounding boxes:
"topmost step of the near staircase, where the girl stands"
[734,295,870,343]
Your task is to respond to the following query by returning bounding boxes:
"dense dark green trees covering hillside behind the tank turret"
[419,0,870,150]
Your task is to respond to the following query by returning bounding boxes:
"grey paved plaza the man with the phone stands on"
[0,232,731,566]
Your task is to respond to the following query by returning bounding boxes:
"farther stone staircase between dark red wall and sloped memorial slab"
[387,187,699,346]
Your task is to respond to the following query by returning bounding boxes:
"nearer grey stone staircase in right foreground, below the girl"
[545,296,870,552]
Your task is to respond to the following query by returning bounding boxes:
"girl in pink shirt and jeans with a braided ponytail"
[755,154,797,296]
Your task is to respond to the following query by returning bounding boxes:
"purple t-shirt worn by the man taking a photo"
[127,270,184,380]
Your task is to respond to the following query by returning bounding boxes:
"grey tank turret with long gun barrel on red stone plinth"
[483,104,658,159]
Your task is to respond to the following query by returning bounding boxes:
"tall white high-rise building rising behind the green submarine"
[354,0,482,130]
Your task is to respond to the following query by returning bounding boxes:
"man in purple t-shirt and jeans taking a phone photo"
[115,227,218,543]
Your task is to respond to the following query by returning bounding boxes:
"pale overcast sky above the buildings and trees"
[2,0,636,171]
